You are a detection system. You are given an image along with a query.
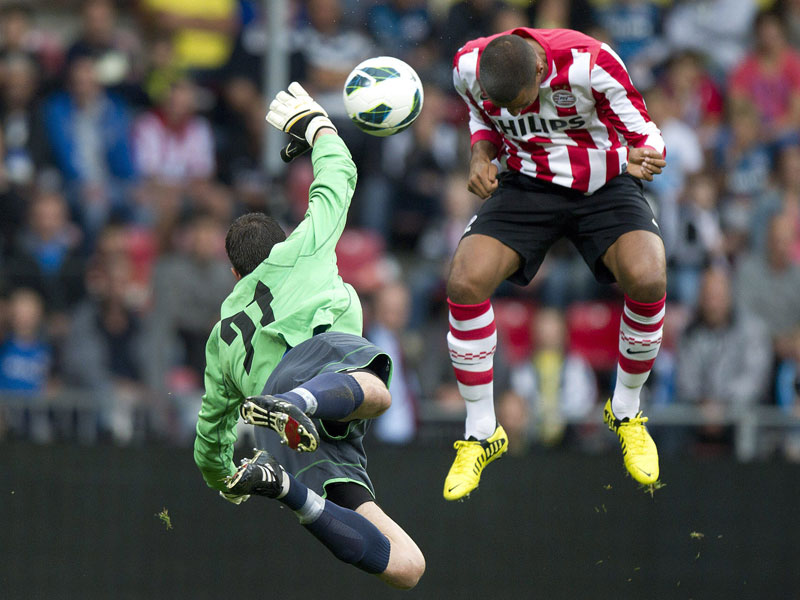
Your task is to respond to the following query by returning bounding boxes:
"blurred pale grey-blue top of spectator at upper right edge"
[664,0,758,74]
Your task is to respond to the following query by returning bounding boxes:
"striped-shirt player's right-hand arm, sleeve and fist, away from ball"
[591,44,667,181]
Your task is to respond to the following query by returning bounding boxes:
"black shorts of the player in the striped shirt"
[464,171,661,285]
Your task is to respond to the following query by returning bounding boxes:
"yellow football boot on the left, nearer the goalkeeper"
[444,425,508,500]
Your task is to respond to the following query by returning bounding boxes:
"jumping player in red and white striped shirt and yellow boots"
[444,28,666,500]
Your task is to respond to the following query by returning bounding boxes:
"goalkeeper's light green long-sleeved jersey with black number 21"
[194,135,362,490]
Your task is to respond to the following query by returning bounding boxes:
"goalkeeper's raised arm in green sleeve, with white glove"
[267,83,357,257]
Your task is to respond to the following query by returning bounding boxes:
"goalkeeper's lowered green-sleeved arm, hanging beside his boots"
[194,323,240,492]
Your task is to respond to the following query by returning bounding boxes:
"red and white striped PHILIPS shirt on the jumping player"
[453,27,666,193]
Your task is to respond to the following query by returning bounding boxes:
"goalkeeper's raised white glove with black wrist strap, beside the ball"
[267,81,336,162]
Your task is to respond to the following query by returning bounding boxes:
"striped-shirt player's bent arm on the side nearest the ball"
[453,62,503,200]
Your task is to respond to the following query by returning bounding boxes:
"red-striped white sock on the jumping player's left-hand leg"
[447,298,497,440]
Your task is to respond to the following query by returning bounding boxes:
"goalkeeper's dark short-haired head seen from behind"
[225,213,286,277]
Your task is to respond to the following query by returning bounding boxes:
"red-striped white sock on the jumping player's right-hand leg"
[611,295,667,419]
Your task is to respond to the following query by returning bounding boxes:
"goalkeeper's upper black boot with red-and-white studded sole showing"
[239,396,319,452]
